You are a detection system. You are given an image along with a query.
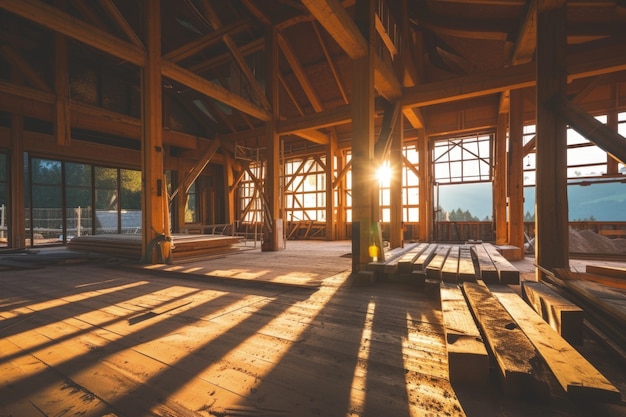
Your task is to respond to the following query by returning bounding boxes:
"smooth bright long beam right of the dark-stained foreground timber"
[491,285,621,402]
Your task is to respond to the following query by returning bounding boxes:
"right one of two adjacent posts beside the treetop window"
[507,90,524,258]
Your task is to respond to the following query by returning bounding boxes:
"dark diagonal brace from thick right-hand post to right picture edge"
[548,95,626,164]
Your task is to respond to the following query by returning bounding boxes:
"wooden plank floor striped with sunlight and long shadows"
[0,241,626,417]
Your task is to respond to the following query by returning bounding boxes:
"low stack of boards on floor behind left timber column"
[67,234,241,261]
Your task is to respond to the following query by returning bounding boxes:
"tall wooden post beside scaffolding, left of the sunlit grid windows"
[261,27,283,251]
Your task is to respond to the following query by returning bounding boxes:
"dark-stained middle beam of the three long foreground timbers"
[463,282,550,401]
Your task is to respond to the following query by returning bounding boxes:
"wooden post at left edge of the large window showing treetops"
[417,129,435,242]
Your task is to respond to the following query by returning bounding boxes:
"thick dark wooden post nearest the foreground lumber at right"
[535,0,569,280]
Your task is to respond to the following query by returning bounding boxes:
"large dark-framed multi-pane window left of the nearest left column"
[25,157,142,246]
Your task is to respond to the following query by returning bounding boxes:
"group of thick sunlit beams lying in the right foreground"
[440,280,621,403]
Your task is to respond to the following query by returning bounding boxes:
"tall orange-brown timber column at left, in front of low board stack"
[141,0,171,263]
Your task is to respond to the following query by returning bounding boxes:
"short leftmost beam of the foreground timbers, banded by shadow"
[440,282,489,385]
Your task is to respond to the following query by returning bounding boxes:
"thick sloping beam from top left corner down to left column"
[0,0,146,67]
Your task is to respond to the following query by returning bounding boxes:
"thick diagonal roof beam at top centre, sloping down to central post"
[302,0,369,59]
